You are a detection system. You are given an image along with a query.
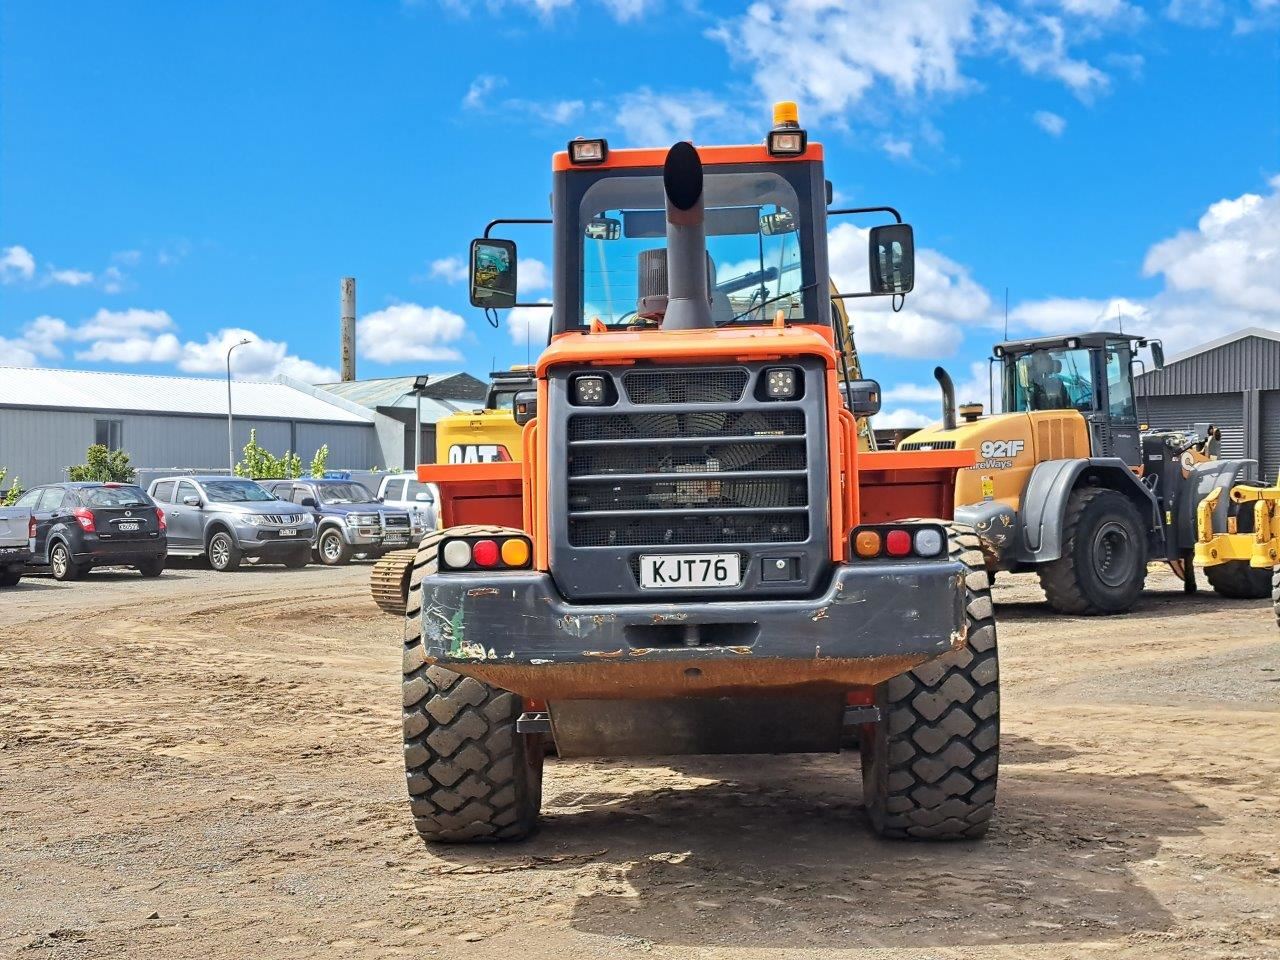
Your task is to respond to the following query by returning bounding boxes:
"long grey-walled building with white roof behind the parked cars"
[0,367,404,488]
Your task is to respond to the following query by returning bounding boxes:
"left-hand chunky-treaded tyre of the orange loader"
[403,526,543,844]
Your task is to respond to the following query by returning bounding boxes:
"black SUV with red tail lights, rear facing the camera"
[14,483,168,580]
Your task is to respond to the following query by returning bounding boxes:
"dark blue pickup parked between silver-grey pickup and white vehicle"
[262,479,422,566]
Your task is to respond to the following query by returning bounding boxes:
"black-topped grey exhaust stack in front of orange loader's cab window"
[662,142,713,330]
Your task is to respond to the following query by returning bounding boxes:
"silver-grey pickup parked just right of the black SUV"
[150,476,316,571]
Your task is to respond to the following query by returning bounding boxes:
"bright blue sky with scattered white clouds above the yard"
[0,0,1280,425]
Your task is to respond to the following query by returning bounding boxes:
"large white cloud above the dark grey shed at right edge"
[1010,177,1280,352]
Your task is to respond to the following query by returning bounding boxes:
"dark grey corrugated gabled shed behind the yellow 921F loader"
[1137,328,1280,480]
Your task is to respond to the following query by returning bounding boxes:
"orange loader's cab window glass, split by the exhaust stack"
[579,170,812,329]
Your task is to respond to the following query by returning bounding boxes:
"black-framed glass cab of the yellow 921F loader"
[995,332,1164,467]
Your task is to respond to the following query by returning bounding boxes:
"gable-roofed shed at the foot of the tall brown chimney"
[319,371,489,467]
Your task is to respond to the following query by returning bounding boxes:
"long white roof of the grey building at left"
[0,366,374,424]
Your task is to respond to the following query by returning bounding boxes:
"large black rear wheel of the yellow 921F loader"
[1038,486,1147,616]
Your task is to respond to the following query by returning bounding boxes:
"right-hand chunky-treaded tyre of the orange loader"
[861,525,1000,840]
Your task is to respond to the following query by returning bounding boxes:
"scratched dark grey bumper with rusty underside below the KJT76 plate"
[422,561,966,699]
